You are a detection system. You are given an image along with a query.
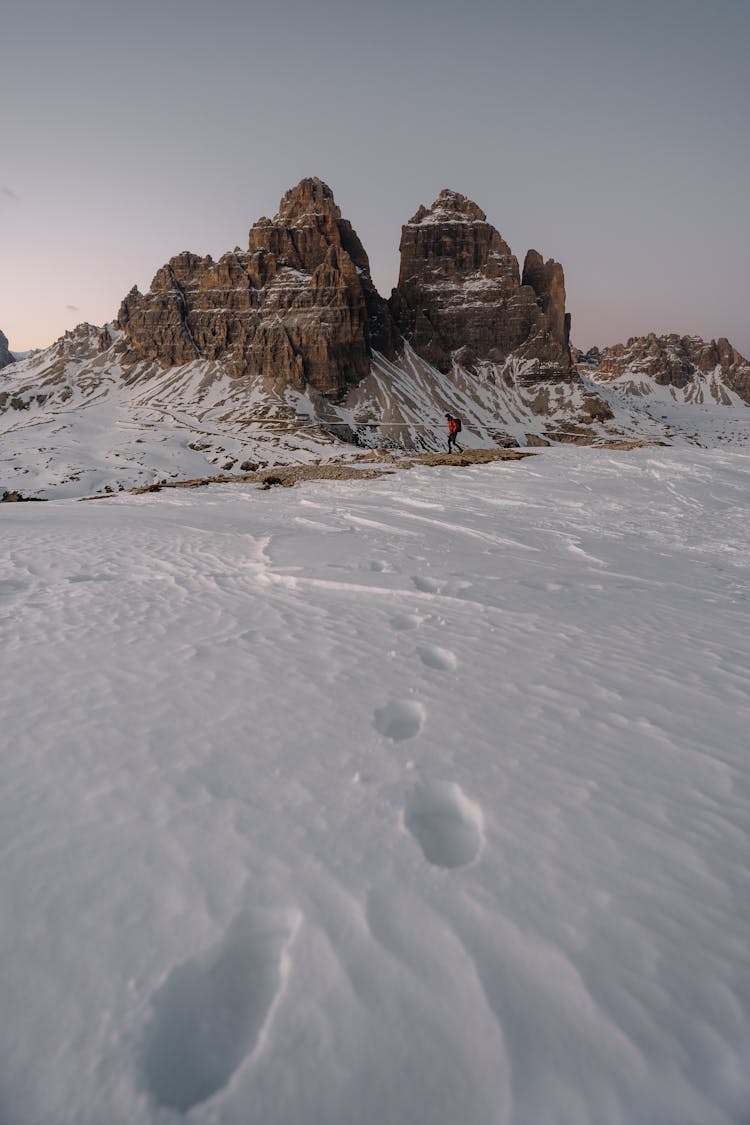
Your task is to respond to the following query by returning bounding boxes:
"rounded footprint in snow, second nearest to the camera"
[404,781,484,867]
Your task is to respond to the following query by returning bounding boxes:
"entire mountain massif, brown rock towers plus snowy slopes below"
[0,179,750,495]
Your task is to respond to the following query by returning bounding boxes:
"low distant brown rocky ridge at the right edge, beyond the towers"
[596,332,750,404]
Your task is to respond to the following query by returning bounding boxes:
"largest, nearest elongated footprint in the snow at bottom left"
[143,914,293,1114]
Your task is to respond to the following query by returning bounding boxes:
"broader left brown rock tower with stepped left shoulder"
[118,179,395,397]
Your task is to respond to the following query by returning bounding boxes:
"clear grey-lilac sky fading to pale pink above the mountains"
[0,0,750,356]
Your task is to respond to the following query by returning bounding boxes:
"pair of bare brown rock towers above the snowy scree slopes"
[118,179,575,401]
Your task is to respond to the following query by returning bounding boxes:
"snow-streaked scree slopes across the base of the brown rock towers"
[0,324,750,497]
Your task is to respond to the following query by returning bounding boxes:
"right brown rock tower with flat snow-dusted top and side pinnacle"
[390,189,571,378]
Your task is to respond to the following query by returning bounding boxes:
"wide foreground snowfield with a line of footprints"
[0,448,750,1125]
